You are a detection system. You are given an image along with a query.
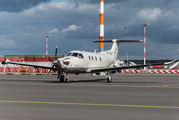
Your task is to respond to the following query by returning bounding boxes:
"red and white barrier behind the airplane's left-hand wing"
[0,56,63,73]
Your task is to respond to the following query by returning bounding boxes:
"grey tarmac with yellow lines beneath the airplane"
[0,73,179,120]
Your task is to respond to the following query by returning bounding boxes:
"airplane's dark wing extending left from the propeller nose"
[1,60,57,71]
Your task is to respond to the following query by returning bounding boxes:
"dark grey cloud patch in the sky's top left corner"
[0,0,51,12]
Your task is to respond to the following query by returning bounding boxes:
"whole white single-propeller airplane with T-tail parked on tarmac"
[2,39,173,82]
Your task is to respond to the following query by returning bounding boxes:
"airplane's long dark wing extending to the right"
[91,60,176,73]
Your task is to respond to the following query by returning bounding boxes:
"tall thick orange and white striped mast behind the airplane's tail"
[99,0,104,52]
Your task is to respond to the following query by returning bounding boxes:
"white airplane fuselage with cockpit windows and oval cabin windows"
[59,51,115,73]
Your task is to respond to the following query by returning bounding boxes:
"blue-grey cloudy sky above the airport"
[0,0,179,60]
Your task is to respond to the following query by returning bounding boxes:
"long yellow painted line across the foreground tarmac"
[0,100,179,109]
